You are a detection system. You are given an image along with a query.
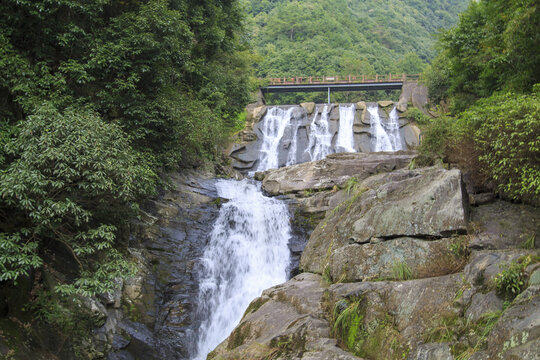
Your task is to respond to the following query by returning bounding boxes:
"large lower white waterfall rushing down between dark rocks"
[196,180,290,359]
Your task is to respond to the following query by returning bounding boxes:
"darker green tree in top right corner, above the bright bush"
[426,0,540,107]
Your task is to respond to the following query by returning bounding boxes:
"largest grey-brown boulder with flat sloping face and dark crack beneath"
[301,167,467,279]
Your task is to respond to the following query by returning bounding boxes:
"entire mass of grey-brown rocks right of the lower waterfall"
[209,153,540,360]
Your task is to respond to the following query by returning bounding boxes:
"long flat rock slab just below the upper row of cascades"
[263,151,415,195]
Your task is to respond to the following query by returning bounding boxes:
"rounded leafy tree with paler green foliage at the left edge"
[0,104,155,295]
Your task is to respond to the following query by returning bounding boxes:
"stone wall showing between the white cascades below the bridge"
[227,101,420,172]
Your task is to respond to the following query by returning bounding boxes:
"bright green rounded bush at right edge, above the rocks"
[468,86,540,204]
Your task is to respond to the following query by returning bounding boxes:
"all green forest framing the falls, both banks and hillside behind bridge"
[0,0,540,358]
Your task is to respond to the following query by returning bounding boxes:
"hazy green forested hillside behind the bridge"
[245,0,469,77]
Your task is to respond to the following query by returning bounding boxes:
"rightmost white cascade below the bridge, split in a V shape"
[368,106,403,152]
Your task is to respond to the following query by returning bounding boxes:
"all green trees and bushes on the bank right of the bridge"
[421,0,540,205]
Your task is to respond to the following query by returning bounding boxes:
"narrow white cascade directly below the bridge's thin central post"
[305,105,332,161]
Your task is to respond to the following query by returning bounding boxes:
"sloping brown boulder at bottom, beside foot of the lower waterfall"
[208,274,359,360]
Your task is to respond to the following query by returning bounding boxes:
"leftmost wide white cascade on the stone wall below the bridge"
[257,106,294,171]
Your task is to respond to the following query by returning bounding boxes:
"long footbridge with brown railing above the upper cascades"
[261,74,420,103]
